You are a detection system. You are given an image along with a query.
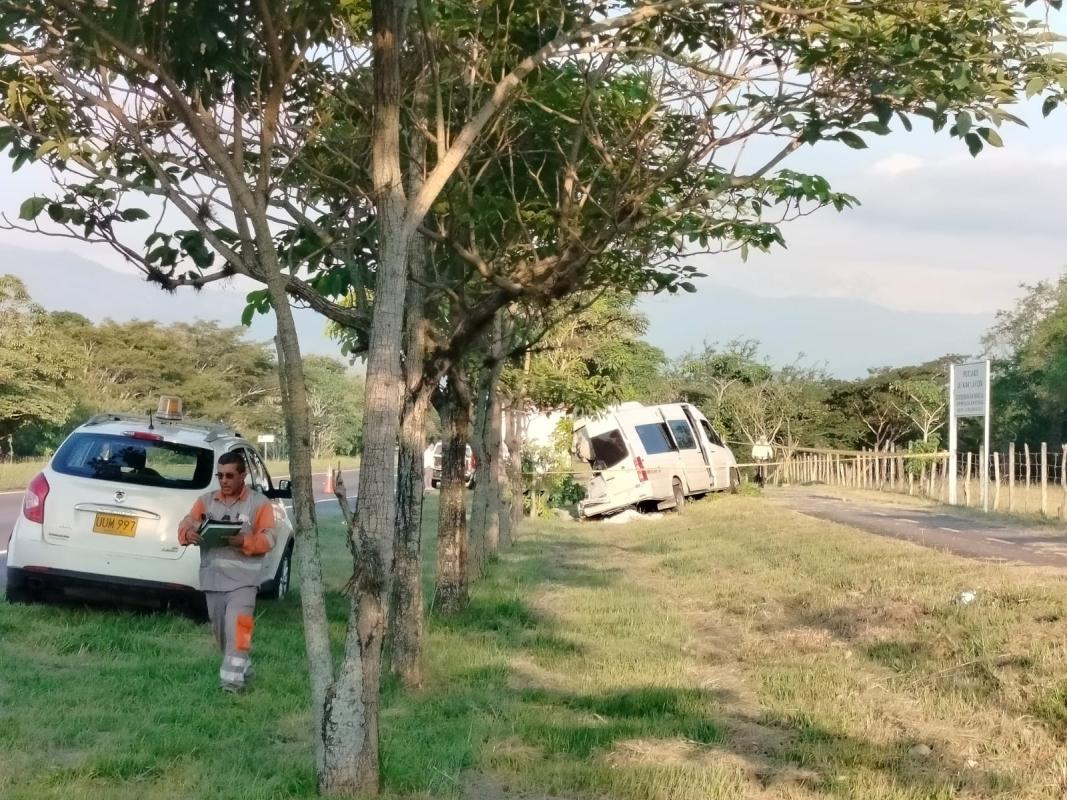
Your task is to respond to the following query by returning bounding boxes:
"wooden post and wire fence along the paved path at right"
[763,443,1067,519]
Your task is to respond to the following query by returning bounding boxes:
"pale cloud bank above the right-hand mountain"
[682,142,1067,314]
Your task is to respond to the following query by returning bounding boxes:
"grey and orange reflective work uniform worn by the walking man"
[190,486,275,689]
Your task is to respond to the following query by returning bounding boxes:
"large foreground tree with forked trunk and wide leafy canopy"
[0,0,1061,793]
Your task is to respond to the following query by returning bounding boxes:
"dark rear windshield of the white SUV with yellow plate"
[52,433,214,489]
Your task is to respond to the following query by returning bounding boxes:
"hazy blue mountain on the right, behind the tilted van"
[640,281,993,378]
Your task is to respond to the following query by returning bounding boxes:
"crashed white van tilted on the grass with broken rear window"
[574,402,740,516]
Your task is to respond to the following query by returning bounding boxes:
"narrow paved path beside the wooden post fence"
[767,487,1067,569]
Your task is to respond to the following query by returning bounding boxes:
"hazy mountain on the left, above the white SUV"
[6,245,339,356]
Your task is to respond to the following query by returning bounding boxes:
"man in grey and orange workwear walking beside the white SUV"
[178,452,274,693]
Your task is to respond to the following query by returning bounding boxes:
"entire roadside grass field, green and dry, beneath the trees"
[0,496,1067,800]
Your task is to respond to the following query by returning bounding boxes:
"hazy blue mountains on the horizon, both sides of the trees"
[6,245,992,378]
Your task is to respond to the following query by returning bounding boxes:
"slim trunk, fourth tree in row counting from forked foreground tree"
[469,317,504,576]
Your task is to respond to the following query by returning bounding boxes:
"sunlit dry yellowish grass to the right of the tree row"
[473,497,1067,800]
